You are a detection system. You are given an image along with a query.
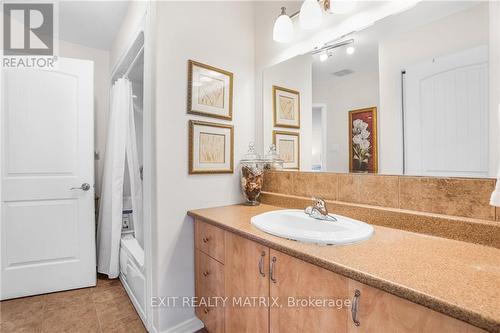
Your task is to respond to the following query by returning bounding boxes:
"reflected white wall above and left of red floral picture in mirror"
[313,69,382,172]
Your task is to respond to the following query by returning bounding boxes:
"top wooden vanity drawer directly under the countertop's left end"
[194,220,224,263]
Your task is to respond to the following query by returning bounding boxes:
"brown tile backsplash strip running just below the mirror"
[263,171,500,221]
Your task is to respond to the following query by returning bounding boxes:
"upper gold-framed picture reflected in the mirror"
[273,86,300,128]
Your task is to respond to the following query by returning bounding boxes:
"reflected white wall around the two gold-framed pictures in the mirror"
[261,55,312,170]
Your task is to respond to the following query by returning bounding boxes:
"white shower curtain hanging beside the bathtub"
[97,78,143,278]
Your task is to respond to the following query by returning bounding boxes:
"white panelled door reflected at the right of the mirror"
[405,46,489,177]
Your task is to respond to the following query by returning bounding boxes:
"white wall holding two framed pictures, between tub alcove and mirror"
[153,2,255,331]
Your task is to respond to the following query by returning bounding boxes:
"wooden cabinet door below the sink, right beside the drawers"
[224,232,269,333]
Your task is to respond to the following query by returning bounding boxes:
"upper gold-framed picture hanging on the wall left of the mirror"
[187,60,233,120]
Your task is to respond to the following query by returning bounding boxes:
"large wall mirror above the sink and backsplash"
[263,1,500,177]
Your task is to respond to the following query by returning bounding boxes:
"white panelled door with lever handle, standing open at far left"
[0,58,96,299]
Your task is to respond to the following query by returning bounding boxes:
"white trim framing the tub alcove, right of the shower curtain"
[108,1,156,332]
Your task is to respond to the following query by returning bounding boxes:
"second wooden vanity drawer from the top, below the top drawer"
[195,250,224,297]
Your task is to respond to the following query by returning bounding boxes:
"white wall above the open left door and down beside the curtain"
[59,41,110,194]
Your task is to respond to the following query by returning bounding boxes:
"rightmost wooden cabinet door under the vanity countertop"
[348,280,484,333]
